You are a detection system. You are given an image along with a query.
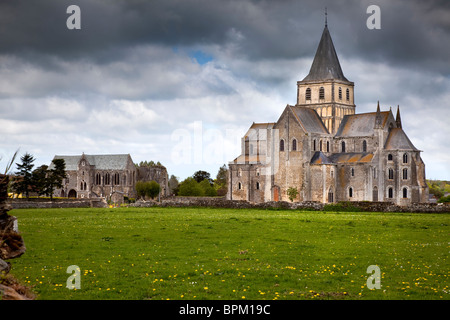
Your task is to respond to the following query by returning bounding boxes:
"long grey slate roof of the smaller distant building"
[49,154,130,171]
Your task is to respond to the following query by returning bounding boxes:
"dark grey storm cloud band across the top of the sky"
[0,0,450,73]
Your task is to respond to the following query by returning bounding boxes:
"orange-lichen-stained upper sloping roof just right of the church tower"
[336,111,390,137]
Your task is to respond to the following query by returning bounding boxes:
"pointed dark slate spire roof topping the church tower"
[303,25,348,81]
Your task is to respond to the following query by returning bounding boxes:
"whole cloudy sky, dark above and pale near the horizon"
[0,0,450,180]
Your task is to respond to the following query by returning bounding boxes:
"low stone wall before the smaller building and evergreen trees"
[8,198,107,209]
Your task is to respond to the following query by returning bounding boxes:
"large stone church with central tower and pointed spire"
[227,25,428,205]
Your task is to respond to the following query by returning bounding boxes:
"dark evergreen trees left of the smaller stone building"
[10,153,66,200]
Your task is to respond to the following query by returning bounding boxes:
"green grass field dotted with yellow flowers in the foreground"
[5,208,450,300]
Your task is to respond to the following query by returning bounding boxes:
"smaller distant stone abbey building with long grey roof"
[50,153,169,203]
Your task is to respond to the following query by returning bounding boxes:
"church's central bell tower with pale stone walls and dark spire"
[297,17,355,134]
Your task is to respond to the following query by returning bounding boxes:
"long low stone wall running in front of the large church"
[130,197,450,213]
